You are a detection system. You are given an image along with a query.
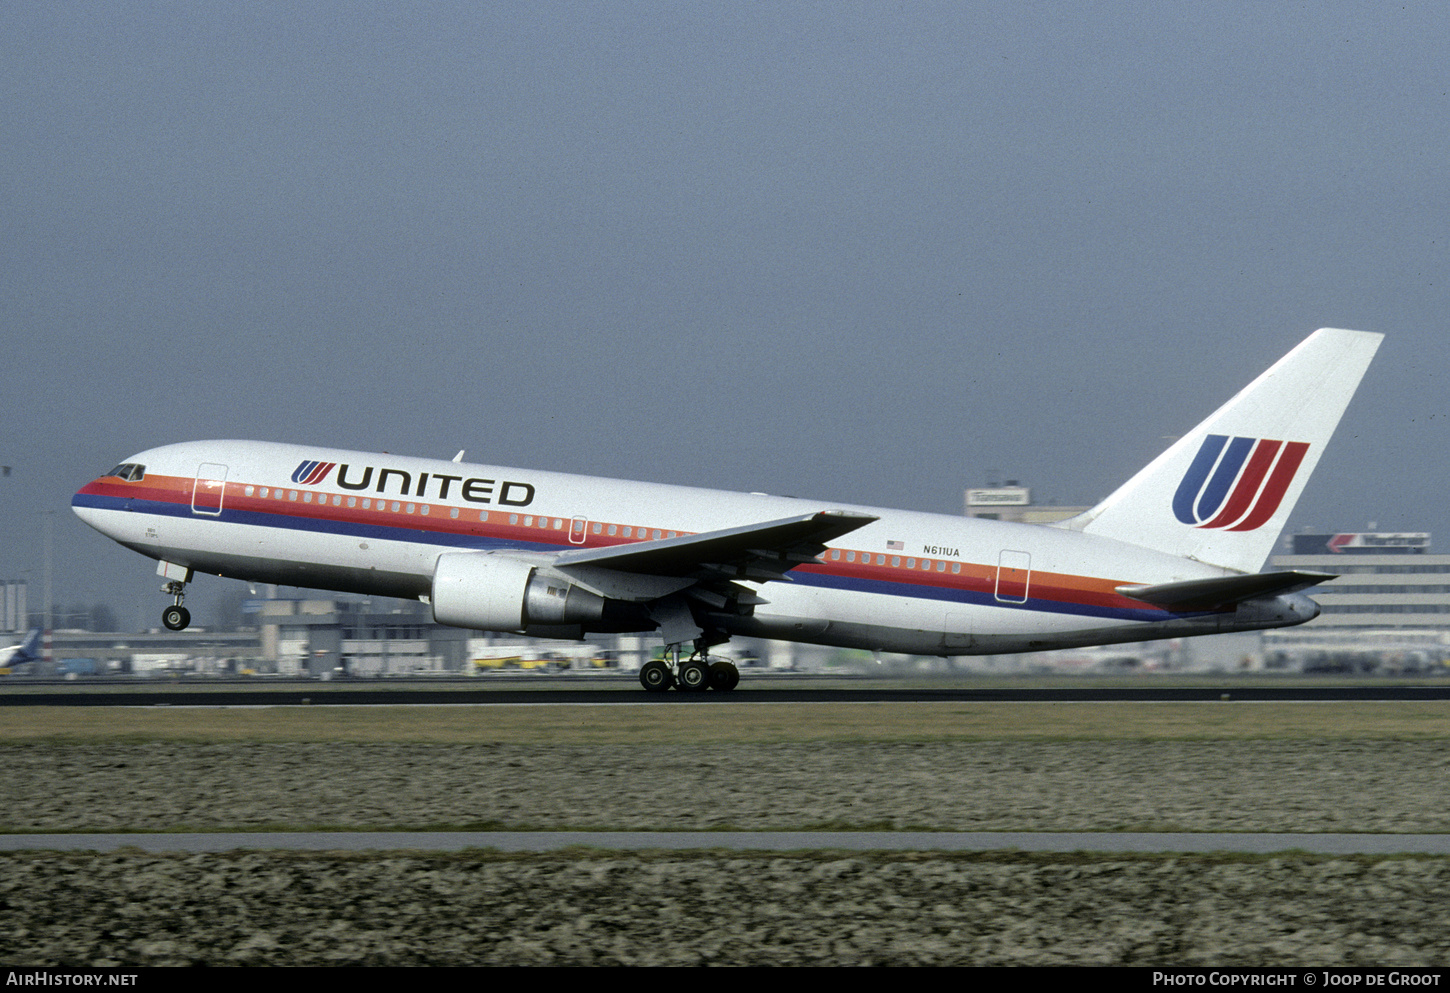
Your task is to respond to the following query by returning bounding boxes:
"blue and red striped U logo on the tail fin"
[1173,435,1309,531]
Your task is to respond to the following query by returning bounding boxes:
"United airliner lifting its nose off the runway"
[71,328,1382,690]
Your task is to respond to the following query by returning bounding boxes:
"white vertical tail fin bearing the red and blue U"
[1061,328,1383,573]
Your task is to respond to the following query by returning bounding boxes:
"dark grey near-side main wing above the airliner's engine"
[552,510,877,606]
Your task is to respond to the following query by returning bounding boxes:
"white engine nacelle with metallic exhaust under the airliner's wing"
[432,552,605,631]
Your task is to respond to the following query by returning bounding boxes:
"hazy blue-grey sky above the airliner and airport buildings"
[0,0,1450,625]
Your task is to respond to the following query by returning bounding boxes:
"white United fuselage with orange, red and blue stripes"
[73,441,1305,655]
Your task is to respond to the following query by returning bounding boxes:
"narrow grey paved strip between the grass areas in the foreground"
[0,831,1450,855]
